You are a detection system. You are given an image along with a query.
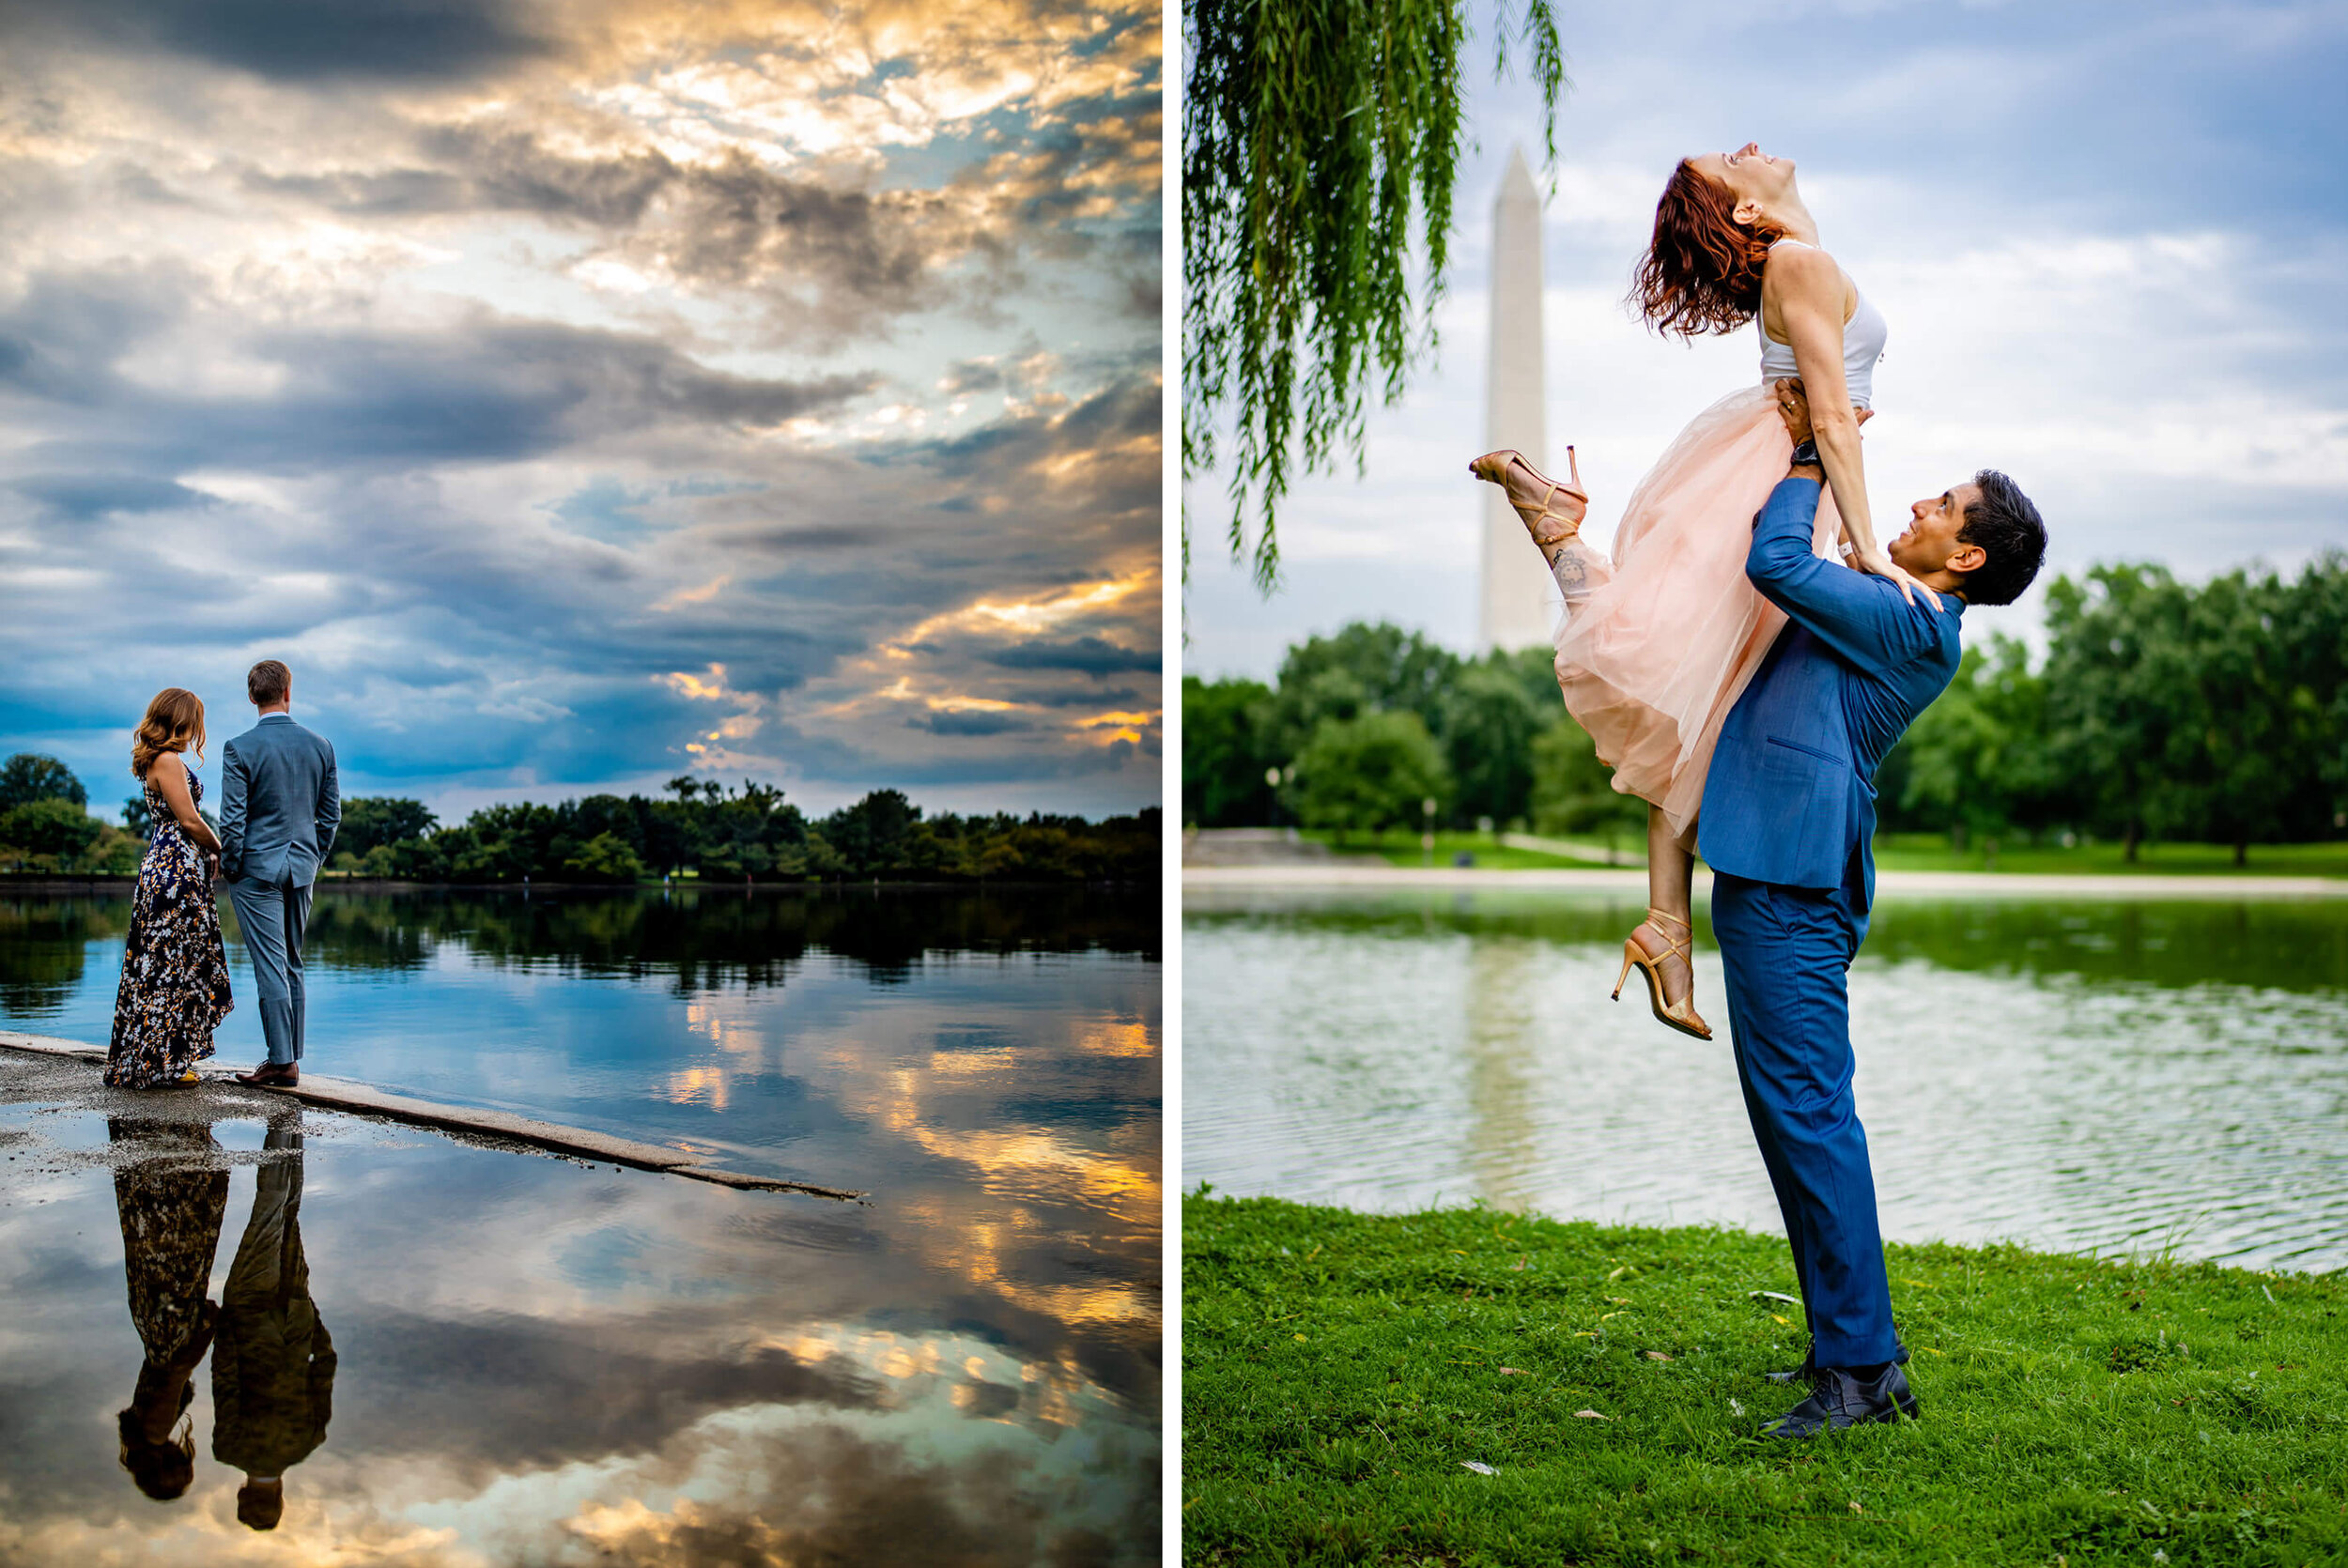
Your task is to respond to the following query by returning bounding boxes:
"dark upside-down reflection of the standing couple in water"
[106,1117,333,1530]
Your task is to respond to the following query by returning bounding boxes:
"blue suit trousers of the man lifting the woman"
[1712,859,1902,1366]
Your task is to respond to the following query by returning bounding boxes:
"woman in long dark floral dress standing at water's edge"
[106,685,235,1089]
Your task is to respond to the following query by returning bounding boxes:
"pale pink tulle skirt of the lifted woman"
[1554,388,1844,848]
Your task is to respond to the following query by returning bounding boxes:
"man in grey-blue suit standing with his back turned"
[221,660,343,1087]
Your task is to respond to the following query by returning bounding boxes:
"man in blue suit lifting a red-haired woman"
[1698,383,2046,1437]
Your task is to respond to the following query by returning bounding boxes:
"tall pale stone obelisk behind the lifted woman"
[1477,148,1557,651]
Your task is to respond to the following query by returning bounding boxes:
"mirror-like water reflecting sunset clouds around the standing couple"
[0,890,1160,1563]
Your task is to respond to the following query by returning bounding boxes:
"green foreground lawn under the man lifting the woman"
[1182,1195,2348,1568]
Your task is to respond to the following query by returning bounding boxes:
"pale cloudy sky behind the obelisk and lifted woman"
[1183,0,2348,676]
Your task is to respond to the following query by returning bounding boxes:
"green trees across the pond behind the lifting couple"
[1183,554,2348,862]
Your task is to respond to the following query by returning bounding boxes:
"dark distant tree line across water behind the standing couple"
[0,770,1163,883]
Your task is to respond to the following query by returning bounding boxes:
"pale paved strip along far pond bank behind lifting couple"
[1182,862,2348,899]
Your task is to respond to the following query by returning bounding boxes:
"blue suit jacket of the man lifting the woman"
[1695,479,1966,911]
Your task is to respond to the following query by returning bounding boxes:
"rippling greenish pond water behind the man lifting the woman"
[1183,890,2348,1270]
